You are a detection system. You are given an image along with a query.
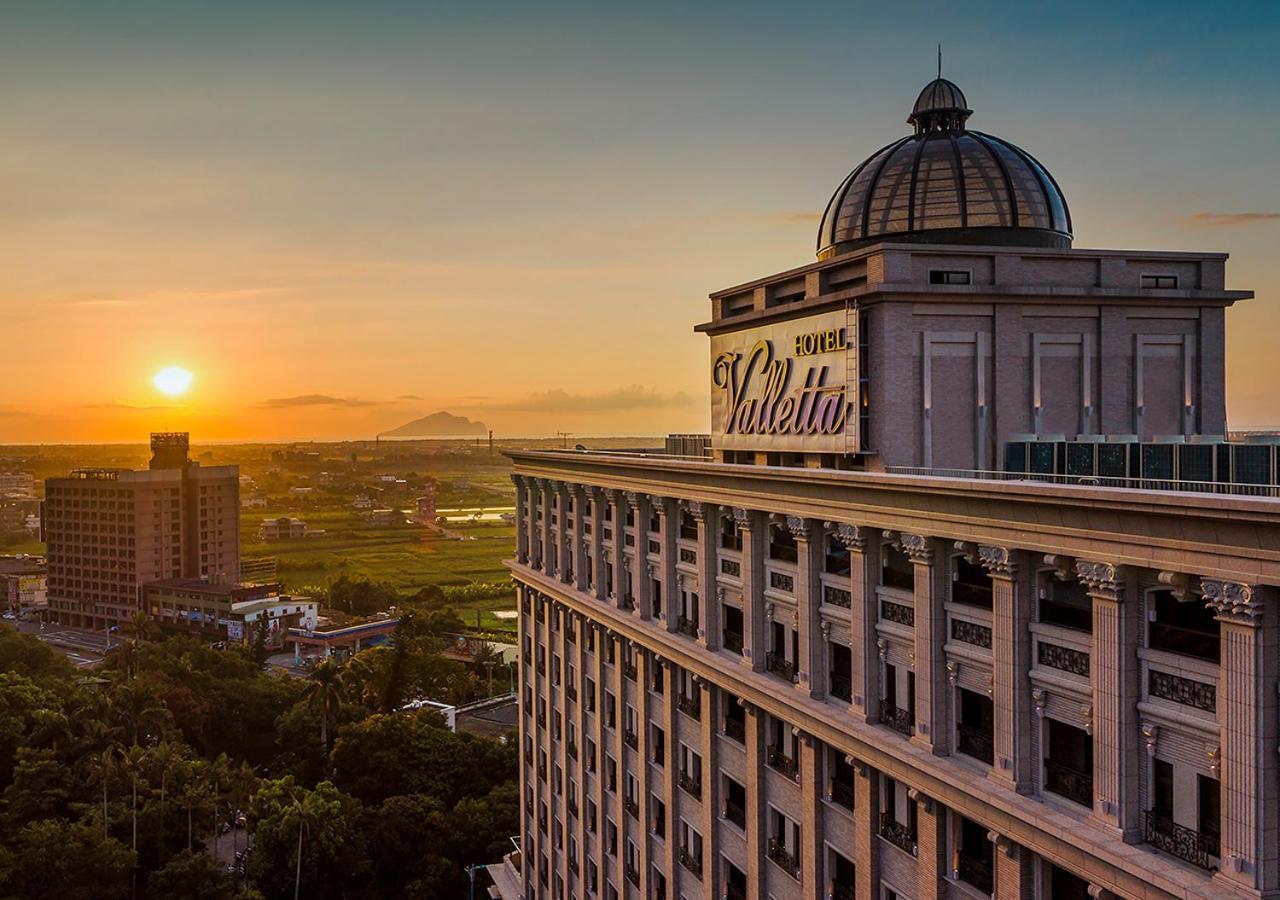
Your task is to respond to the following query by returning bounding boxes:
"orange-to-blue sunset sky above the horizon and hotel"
[0,3,1280,443]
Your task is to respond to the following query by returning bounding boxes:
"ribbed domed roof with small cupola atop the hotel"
[818,78,1071,259]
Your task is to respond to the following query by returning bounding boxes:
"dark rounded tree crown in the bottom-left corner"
[5,819,136,900]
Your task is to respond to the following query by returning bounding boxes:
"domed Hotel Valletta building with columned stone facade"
[508,79,1280,900]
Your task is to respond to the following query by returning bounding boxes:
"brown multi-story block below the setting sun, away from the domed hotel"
[41,434,239,629]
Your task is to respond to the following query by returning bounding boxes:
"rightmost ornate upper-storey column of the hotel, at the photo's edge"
[1201,579,1280,896]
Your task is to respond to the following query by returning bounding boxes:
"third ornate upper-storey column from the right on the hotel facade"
[978,544,1036,794]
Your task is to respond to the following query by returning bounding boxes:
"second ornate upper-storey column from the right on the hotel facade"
[1075,559,1142,841]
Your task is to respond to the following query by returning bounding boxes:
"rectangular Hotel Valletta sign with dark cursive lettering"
[712,309,858,453]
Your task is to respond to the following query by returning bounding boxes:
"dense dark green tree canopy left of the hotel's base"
[0,619,518,900]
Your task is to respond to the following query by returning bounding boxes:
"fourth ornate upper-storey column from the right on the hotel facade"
[899,534,951,757]
